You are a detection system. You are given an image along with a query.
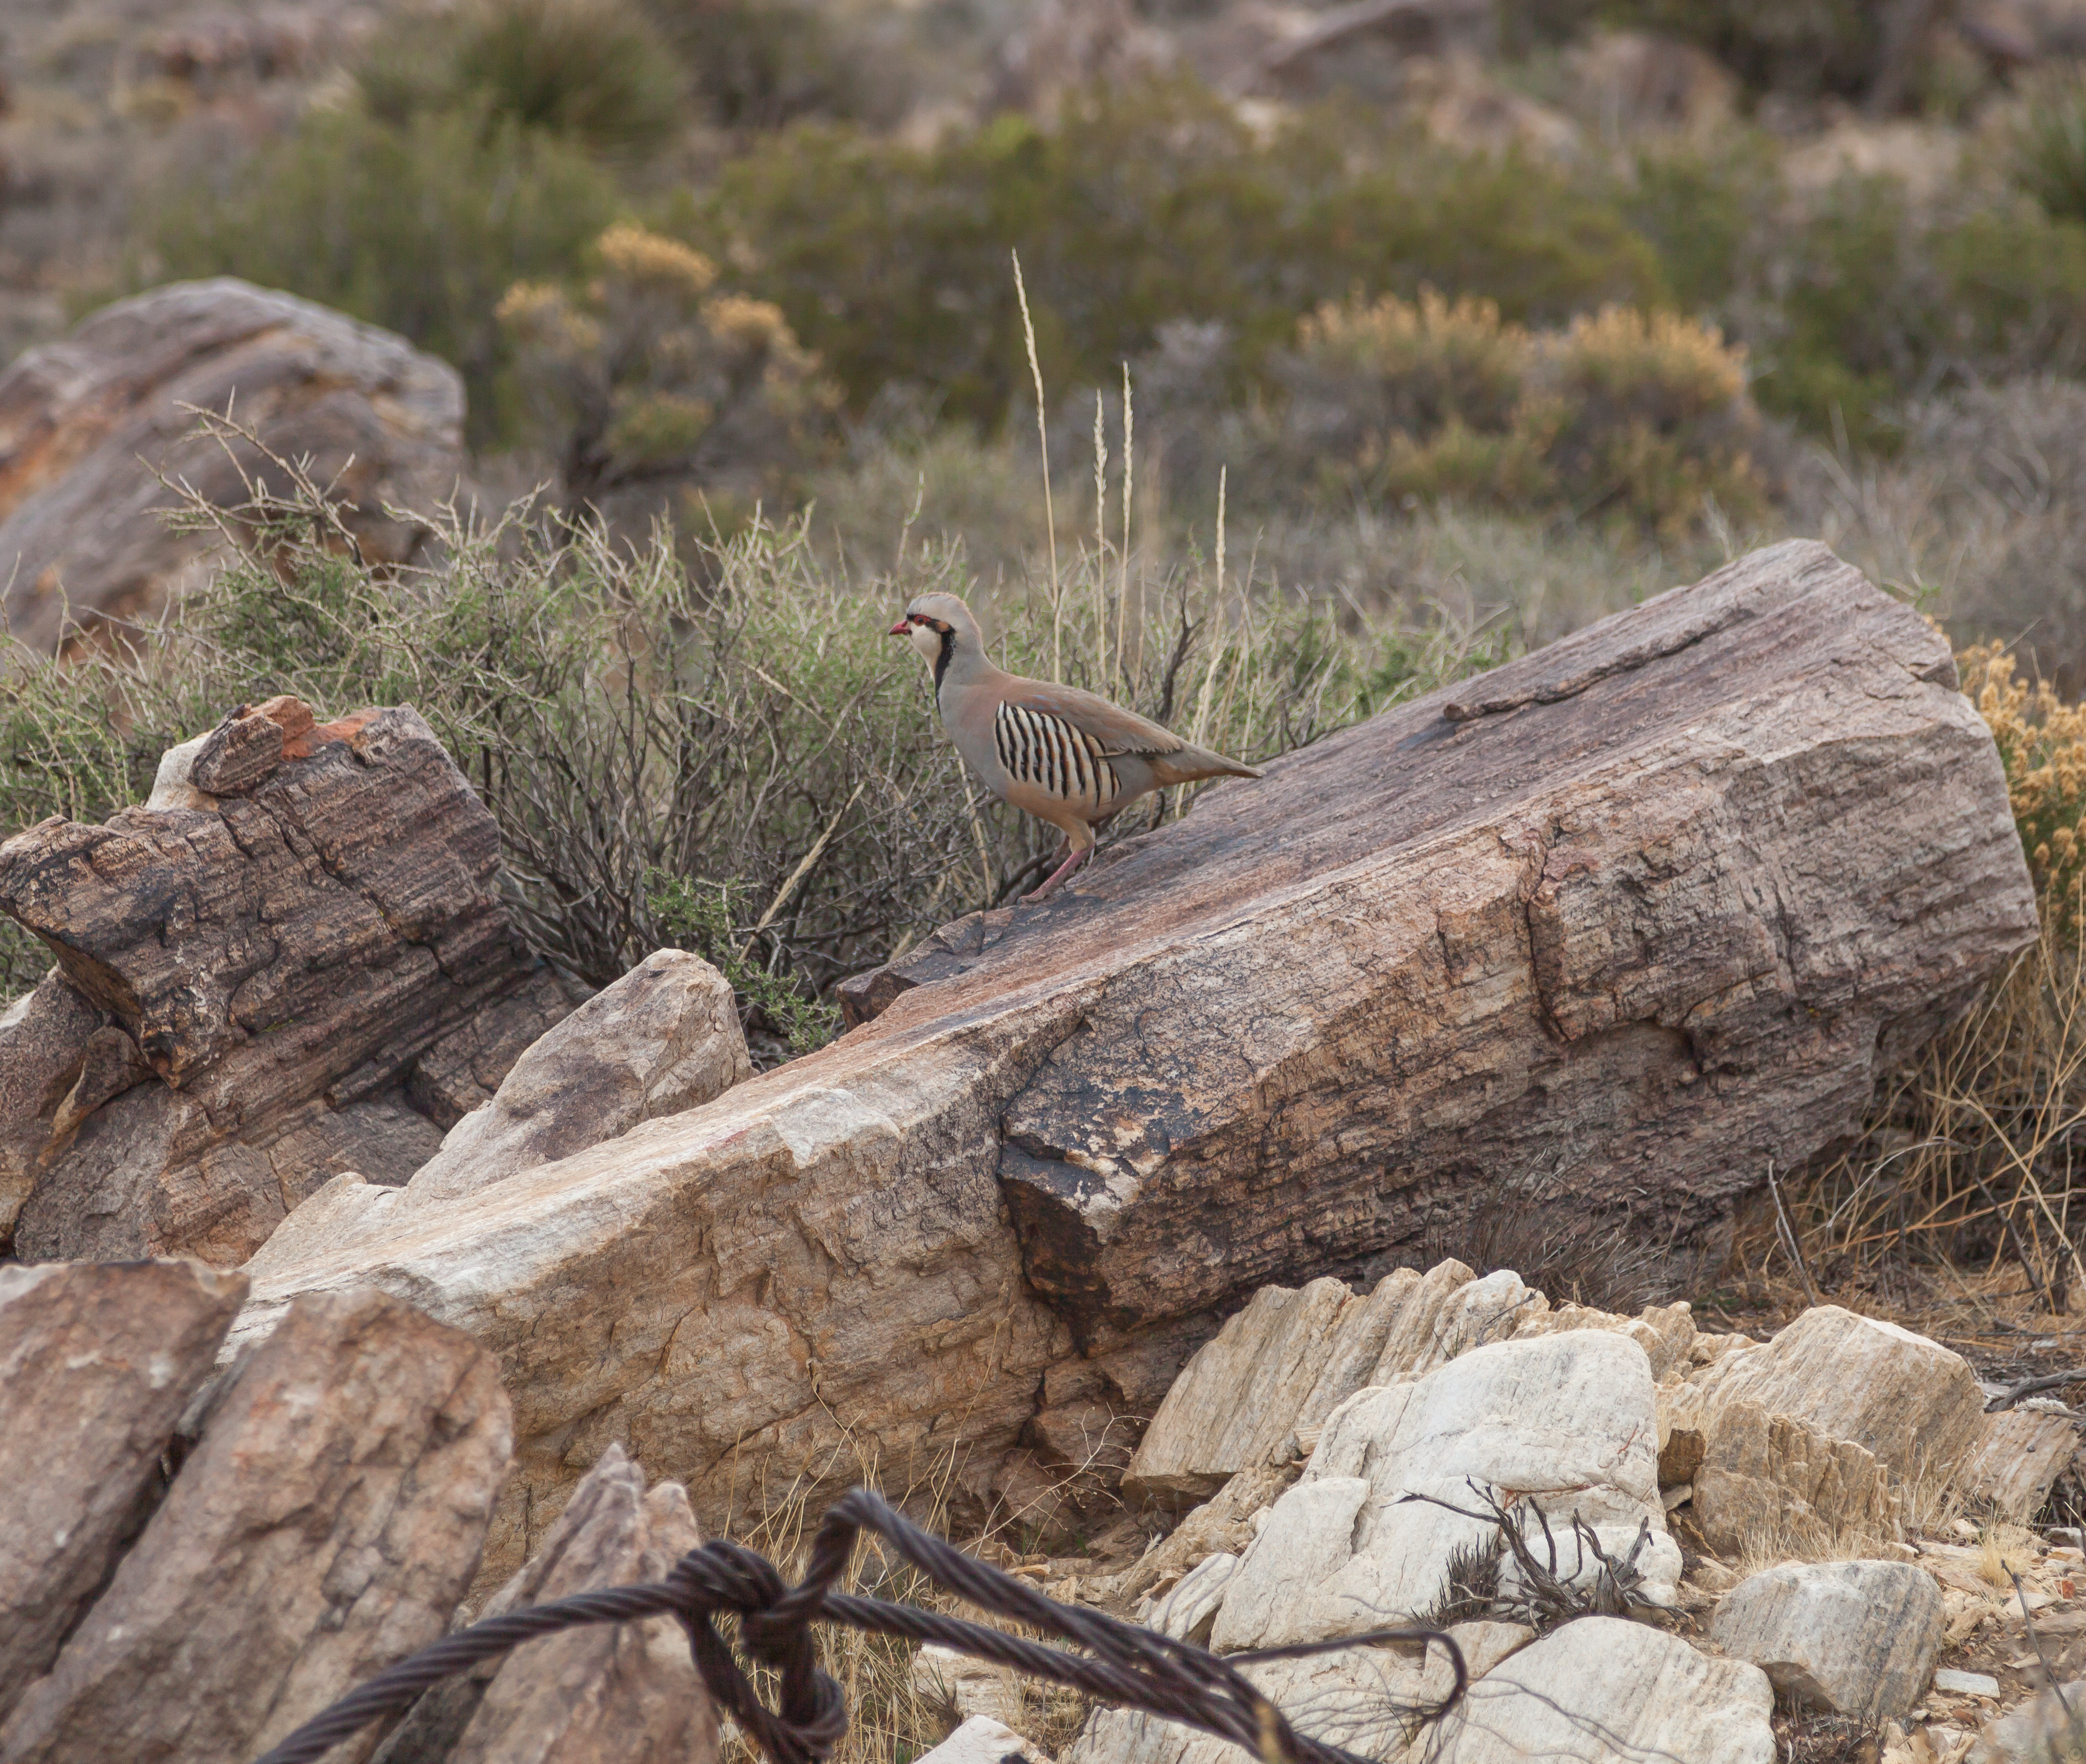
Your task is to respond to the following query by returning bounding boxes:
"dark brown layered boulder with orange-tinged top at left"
[0,699,573,1266]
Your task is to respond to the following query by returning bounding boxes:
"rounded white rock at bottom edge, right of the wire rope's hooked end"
[1437,1618,1775,1764]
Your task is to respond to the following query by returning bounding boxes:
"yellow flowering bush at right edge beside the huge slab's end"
[1956,642,2086,934]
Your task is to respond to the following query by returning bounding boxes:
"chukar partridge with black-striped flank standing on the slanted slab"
[891,594,1260,901]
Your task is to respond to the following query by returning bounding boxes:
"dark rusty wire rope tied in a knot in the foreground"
[256,1489,1467,1764]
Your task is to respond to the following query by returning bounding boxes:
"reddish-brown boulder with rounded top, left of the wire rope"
[0,1291,511,1764]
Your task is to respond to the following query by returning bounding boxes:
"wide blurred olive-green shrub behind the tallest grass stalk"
[672,82,1659,427]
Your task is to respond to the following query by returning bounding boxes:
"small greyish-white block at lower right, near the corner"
[1709,1561,1946,1718]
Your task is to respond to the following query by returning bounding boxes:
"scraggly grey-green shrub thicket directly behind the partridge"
[0,442,1485,1047]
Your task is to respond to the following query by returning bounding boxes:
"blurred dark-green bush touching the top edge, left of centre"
[357,0,689,156]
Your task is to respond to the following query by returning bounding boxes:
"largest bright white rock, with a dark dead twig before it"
[1212,1330,1679,1649]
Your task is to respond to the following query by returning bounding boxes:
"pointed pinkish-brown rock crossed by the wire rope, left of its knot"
[374,1447,717,1764]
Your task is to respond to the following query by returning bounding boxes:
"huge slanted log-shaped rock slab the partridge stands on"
[242,542,2036,1572]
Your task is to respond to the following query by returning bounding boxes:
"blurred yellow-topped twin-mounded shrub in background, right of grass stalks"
[1274,294,1760,534]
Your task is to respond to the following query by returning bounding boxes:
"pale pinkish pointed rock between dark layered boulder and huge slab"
[246,949,753,1278]
